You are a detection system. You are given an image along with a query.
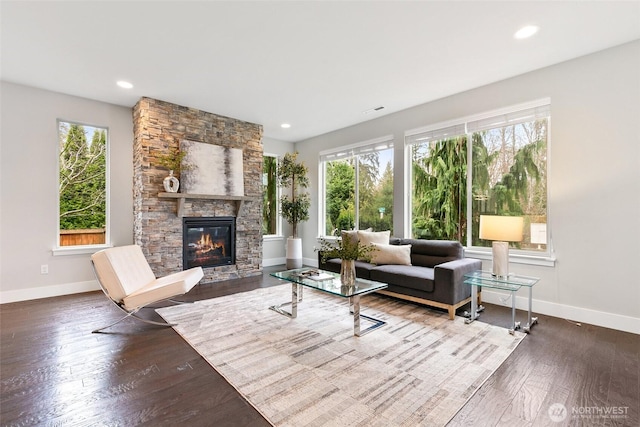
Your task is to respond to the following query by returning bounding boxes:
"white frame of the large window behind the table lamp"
[404,98,556,266]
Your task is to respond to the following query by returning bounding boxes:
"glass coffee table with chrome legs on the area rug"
[269,268,387,337]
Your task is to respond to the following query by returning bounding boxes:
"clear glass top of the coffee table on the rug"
[271,268,387,298]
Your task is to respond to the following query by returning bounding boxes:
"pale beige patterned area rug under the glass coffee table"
[156,285,524,427]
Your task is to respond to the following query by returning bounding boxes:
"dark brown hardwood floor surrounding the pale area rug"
[0,268,640,427]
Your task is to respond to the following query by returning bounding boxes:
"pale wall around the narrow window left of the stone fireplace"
[0,82,133,302]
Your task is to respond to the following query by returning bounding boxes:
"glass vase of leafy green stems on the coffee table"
[320,235,374,286]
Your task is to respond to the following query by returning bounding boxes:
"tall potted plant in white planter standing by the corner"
[277,152,311,269]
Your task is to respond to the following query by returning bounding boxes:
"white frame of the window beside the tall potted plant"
[318,135,395,240]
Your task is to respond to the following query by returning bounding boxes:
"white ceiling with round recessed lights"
[0,0,640,142]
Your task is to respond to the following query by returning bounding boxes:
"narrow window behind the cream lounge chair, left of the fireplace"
[58,121,108,247]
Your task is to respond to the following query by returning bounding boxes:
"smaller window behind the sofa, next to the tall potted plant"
[320,136,393,236]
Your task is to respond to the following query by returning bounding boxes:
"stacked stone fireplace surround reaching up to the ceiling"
[133,98,263,283]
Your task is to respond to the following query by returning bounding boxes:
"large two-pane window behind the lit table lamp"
[405,100,550,253]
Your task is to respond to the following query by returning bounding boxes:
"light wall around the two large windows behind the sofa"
[296,41,640,333]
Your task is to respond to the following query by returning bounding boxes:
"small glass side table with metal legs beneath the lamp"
[464,270,540,335]
